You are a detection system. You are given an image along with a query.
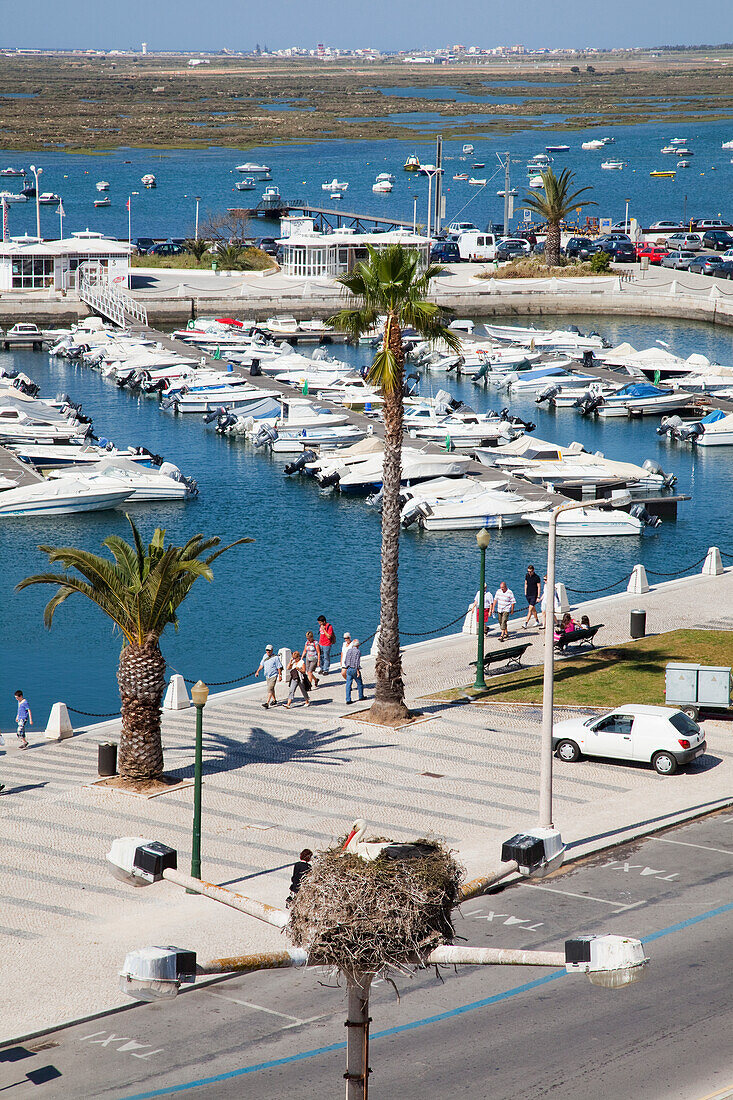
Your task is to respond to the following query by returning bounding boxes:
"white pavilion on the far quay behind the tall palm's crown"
[277,218,429,278]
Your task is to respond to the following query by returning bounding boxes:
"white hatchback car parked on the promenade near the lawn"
[553,703,707,776]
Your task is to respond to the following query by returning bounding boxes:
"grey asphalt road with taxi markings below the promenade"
[0,811,733,1100]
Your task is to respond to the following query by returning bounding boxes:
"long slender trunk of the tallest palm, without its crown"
[371,317,409,723]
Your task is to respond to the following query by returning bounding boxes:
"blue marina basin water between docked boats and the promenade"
[0,317,733,729]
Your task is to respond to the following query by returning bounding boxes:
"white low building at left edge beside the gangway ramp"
[0,229,130,290]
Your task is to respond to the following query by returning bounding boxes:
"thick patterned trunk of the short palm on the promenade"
[117,637,165,781]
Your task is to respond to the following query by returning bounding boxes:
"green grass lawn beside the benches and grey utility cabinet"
[431,630,733,706]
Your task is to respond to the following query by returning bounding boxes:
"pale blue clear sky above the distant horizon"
[0,0,733,51]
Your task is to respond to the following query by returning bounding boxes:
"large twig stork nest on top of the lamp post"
[286,838,464,977]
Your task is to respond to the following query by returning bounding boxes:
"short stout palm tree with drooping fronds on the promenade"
[18,516,253,781]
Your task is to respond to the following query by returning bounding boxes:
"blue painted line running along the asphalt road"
[119,902,733,1100]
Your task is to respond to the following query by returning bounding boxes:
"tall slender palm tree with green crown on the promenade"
[328,244,460,723]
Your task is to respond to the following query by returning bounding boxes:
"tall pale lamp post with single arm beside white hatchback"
[539,493,631,828]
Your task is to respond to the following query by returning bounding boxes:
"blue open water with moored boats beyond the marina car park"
[2,113,733,245]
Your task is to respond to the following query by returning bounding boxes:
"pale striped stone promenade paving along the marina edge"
[0,571,733,1041]
